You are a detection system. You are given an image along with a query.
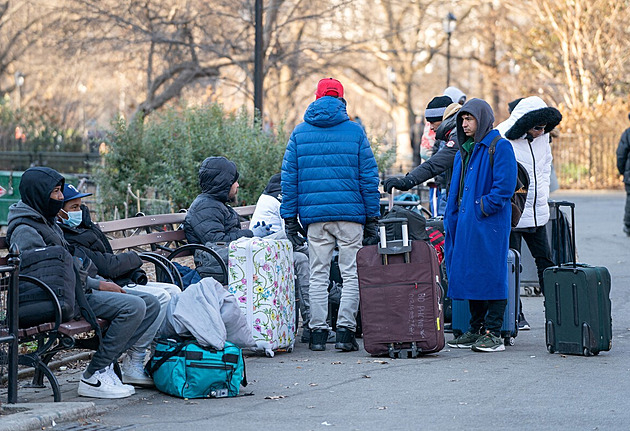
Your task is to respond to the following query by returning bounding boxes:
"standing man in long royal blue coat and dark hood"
[444,99,517,352]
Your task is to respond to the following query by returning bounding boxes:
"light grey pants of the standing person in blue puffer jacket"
[308,221,363,331]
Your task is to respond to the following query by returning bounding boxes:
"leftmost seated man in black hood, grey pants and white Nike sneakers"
[7,167,160,398]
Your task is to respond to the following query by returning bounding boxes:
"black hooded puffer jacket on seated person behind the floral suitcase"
[184,157,254,244]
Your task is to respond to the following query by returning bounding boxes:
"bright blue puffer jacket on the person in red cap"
[280,96,380,226]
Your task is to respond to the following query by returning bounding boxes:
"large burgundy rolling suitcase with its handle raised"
[357,219,444,358]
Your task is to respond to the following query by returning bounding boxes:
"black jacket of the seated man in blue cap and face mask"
[59,205,142,284]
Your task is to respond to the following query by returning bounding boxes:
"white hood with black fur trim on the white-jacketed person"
[497,96,562,140]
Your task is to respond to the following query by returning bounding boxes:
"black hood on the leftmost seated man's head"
[20,167,65,223]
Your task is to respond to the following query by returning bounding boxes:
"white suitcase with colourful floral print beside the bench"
[228,238,296,351]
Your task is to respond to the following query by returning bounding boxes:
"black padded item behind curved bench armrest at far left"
[18,245,80,328]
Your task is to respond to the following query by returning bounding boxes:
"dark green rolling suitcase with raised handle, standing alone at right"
[544,202,612,356]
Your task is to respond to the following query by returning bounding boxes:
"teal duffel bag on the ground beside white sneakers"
[147,340,247,398]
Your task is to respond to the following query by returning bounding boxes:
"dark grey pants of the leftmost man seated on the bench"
[86,289,160,375]
